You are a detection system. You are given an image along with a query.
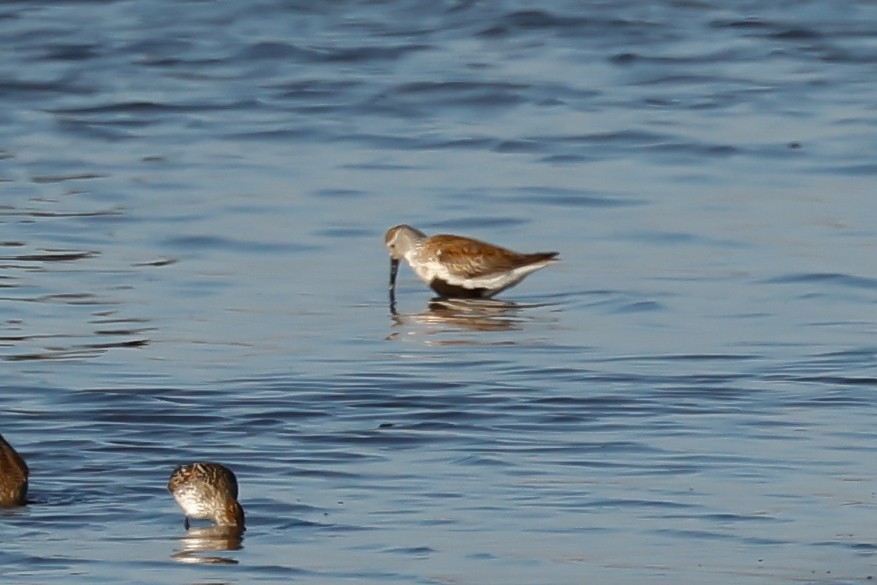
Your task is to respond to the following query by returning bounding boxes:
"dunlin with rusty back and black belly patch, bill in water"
[384,225,558,304]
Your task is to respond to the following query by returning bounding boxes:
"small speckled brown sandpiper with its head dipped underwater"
[167,463,244,532]
